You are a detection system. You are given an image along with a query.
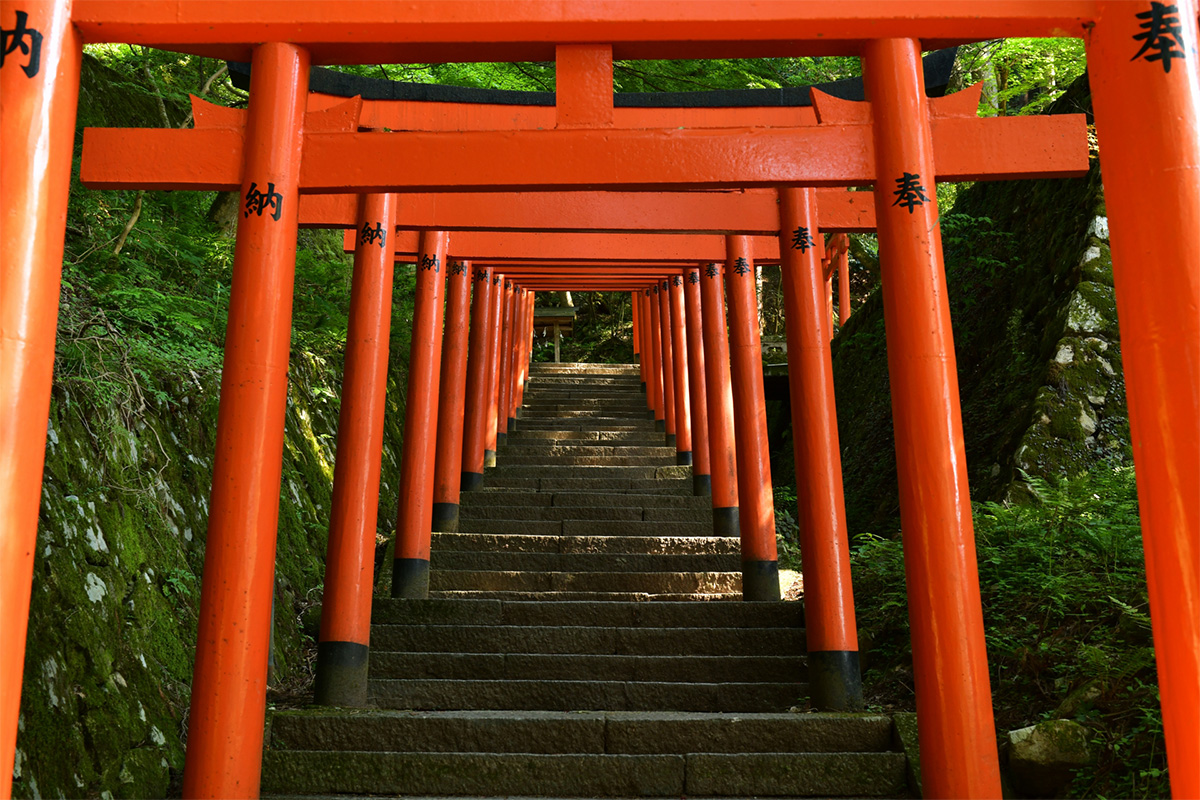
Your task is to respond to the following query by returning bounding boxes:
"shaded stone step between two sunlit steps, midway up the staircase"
[430,551,742,575]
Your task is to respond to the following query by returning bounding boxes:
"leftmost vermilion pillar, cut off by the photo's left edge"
[0,0,82,798]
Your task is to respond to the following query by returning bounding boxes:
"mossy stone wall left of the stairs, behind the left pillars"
[13,354,403,798]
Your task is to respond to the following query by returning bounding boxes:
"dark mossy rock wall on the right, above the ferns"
[833,79,1129,534]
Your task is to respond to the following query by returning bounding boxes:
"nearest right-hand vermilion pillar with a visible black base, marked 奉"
[779,188,863,711]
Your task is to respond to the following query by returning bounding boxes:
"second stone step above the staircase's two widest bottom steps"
[371,652,806,682]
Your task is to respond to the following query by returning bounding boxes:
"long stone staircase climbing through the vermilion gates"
[263,365,907,798]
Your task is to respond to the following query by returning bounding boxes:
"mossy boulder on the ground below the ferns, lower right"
[1008,720,1092,798]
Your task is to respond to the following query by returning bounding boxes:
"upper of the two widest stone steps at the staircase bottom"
[270,709,892,754]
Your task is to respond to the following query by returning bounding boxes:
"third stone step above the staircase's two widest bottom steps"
[371,624,805,656]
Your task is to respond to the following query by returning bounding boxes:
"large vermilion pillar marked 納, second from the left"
[184,42,308,798]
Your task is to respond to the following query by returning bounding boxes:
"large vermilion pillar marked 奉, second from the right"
[863,40,1001,798]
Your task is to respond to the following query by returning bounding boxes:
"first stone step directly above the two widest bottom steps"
[370,679,808,712]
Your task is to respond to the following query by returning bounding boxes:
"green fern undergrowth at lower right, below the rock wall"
[852,467,1168,798]
